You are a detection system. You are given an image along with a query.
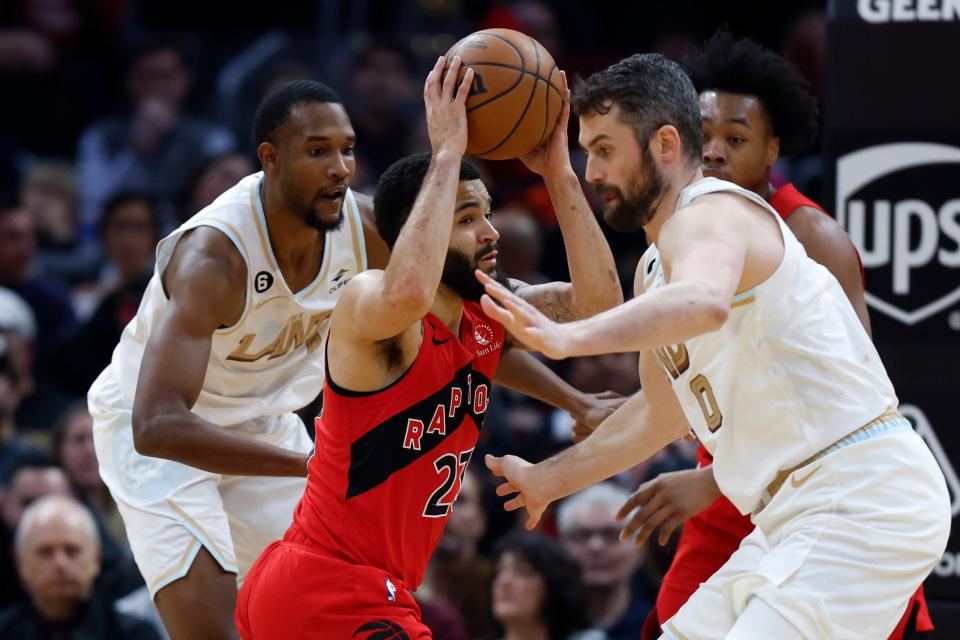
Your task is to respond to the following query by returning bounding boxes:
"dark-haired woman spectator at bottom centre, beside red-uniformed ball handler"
[492,533,606,640]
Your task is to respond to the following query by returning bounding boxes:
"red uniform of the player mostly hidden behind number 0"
[653,183,933,640]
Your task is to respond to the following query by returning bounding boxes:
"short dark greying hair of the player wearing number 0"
[572,53,703,165]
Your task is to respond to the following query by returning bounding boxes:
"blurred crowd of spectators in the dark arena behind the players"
[0,0,825,640]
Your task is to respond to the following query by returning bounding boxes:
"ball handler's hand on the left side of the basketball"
[423,56,473,156]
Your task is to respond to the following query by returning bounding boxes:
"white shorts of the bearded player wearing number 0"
[662,418,951,640]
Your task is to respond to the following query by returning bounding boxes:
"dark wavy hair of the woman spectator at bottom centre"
[494,532,590,638]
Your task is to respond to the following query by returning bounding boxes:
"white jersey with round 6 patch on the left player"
[90,172,367,426]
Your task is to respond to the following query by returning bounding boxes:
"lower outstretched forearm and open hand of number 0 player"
[486,352,690,529]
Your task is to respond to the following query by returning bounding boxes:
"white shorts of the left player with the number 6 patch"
[90,390,313,596]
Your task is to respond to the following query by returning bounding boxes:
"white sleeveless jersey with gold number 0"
[641,178,897,514]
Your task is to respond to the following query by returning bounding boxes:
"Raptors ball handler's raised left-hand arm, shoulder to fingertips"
[331,57,473,341]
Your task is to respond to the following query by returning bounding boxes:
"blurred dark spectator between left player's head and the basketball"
[347,39,423,191]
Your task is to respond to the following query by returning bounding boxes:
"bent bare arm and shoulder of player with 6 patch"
[133,228,307,476]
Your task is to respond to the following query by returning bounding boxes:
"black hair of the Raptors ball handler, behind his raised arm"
[373,153,480,249]
